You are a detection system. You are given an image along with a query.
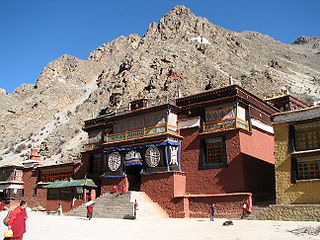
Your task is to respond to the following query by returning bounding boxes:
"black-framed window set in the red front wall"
[201,137,227,168]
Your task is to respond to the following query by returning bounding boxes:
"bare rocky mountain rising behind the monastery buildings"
[0,6,320,165]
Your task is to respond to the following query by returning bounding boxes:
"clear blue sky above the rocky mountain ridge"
[0,0,320,93]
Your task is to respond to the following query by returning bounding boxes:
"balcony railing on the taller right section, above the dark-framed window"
[203,118,249,132]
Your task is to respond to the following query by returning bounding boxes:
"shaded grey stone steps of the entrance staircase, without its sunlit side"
[65,192,133,218]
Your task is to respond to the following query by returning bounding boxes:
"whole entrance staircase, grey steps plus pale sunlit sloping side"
[65,191,169,219]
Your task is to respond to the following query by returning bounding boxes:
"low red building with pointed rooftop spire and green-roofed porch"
[21,147,96,212]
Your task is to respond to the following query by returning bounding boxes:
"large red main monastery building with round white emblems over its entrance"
[82,85,279,217]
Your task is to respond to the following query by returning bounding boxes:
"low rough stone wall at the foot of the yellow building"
[249,204,320,221]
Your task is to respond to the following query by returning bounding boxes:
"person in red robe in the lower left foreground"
[8,200,28,240]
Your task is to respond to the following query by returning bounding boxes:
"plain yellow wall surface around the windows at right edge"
[273,123,320,204]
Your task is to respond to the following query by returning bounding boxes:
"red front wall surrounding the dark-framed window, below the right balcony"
[180,128,245,194]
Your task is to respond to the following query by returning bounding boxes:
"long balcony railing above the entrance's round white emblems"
[105,124,179,142]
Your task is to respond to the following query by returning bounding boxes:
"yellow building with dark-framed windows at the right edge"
[272,106,320,204]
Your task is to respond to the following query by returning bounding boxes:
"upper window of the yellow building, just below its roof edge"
[294,122,320,151]
